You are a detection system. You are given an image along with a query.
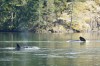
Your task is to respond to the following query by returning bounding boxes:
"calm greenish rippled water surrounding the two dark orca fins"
[0,32,100,66]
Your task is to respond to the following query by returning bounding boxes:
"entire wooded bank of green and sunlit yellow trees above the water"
[0,0,100,33]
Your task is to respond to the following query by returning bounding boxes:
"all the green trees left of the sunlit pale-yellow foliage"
[0,0,91,31]
